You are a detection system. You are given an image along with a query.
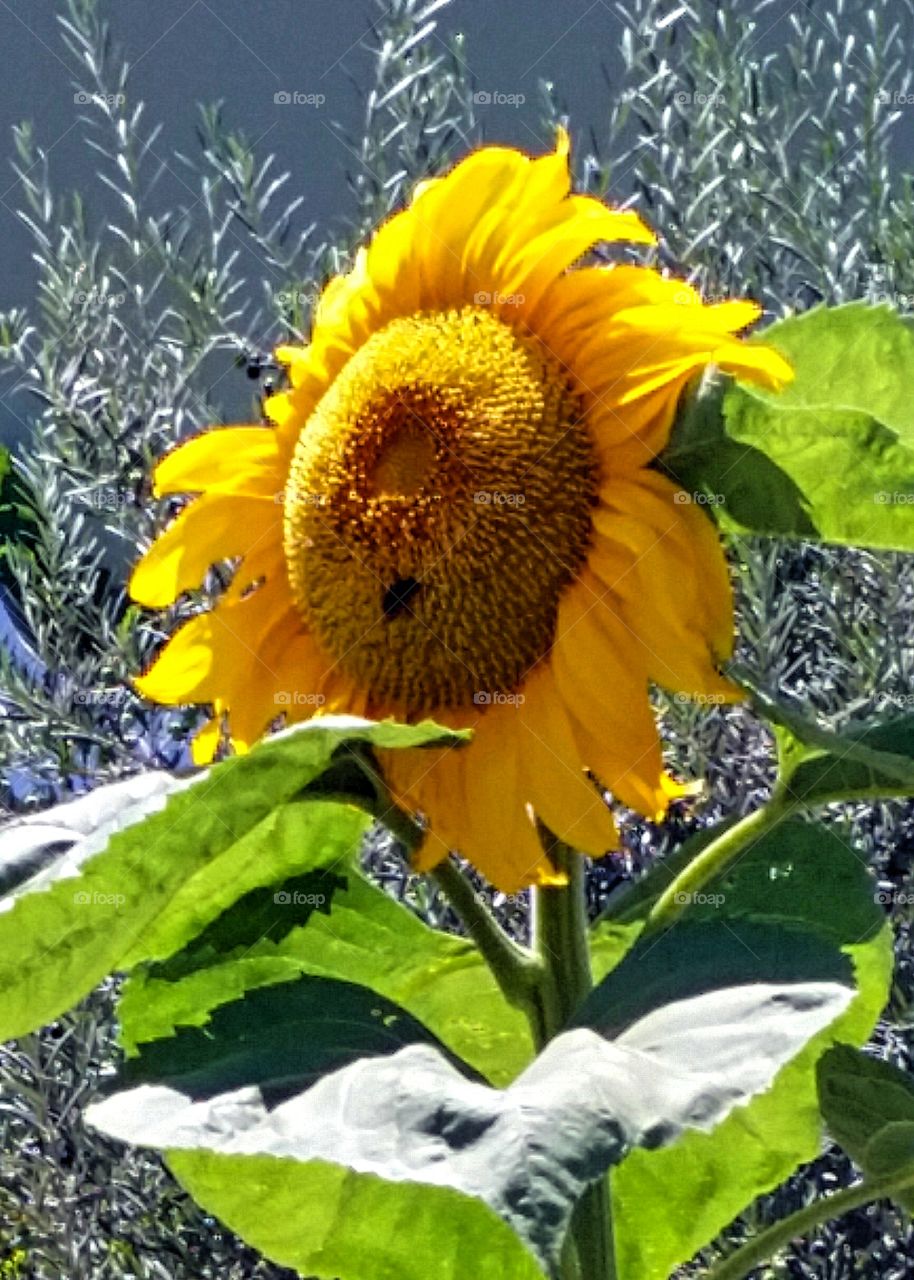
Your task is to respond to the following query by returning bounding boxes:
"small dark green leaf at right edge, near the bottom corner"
[817,1044,914,1211]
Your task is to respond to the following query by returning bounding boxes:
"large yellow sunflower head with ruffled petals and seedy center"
[131,131,791,892]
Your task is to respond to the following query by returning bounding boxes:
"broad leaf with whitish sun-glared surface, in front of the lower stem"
[88,982,851,1280]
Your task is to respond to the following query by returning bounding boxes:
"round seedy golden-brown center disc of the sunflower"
[284,307,597,713]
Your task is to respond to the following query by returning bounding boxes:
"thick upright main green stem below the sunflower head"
[533,828,616,1280]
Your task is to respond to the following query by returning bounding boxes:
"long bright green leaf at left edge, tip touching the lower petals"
[0,717,465,1039]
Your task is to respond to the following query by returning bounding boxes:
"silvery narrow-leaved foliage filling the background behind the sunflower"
[0,0,914,1280]
